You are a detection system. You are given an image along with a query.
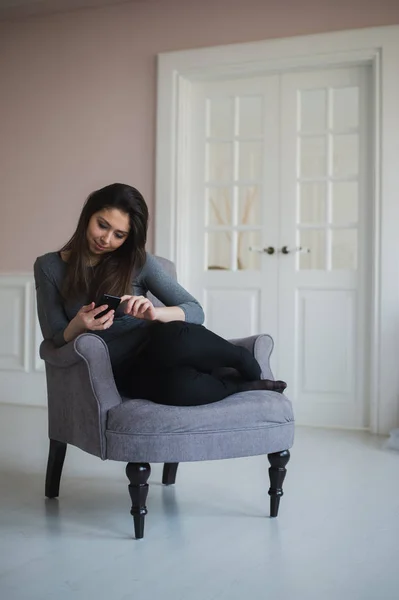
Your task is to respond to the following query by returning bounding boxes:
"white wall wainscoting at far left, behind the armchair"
[0,273,46,406]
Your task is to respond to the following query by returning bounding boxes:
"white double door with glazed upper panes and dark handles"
[187,67,372,428]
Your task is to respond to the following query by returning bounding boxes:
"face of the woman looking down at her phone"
[86,208,130,257]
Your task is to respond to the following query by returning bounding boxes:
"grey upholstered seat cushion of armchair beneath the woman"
[105,391,294,462]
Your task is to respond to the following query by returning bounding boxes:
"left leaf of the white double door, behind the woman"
[189,76,279,350]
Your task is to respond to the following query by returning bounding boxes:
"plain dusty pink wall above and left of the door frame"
[0,0,399,272]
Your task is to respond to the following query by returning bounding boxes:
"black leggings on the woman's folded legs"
[115,321,261,406]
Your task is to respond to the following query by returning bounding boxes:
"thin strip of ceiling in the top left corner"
[0,0,145,21]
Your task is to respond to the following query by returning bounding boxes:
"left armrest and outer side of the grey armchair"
[40,333,122,459]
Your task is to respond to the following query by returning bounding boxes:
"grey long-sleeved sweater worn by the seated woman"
[34,252,204,366]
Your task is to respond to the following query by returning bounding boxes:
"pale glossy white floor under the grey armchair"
[0,405,399,600]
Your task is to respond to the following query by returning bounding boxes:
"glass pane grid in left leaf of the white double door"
[204,95,264,271]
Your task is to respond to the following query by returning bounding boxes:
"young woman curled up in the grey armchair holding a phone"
[34,183,286,406]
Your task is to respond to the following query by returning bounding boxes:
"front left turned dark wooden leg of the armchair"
[126,463,151,540]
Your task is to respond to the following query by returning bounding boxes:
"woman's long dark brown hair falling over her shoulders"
[61,183,148,302]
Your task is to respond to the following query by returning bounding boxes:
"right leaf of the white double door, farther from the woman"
[276,68,369,428]
